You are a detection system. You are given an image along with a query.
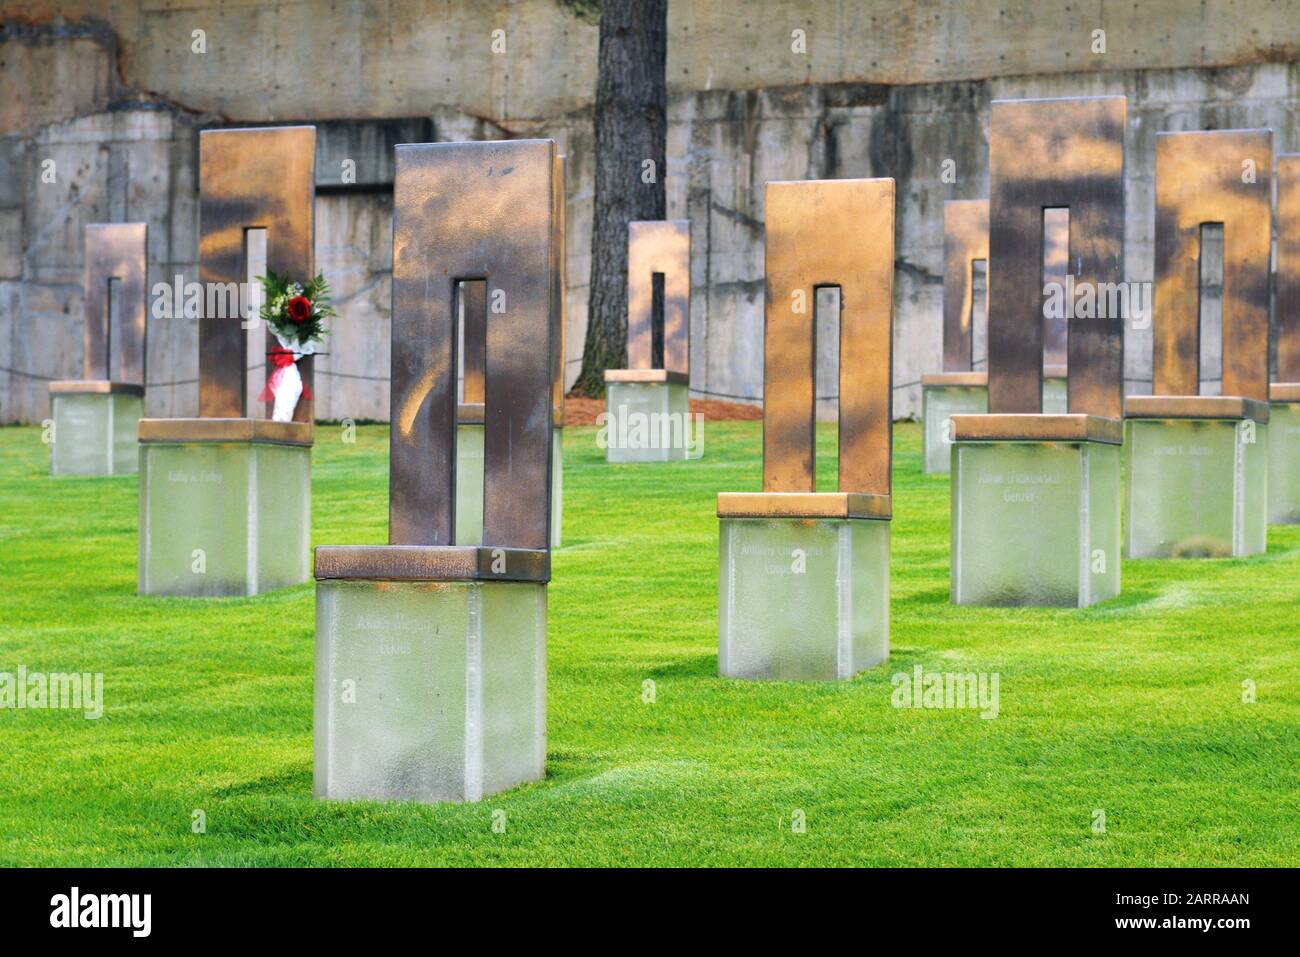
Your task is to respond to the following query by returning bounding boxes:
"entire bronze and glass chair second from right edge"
[1125,130,1284,558]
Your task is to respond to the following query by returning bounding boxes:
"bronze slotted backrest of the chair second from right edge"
[1152,130,1273,402]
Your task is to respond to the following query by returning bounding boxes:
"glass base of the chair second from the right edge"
[1125,419,1269,558]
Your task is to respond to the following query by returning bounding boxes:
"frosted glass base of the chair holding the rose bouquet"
[138,419,312,597]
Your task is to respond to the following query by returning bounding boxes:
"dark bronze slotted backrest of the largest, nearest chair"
[389,139,556,549]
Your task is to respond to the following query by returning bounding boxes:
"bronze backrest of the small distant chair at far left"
[82,222,148,386]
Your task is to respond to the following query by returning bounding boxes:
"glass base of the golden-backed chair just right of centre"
[718,518,889,681]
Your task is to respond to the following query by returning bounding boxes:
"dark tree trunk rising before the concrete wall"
[573,0,668,398]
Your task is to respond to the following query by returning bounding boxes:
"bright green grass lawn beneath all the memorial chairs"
[0,423,1300,866]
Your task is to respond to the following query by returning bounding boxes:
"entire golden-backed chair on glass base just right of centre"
[718,179,894,680]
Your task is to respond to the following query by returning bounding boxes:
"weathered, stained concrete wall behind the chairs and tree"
[0,0,1300,421]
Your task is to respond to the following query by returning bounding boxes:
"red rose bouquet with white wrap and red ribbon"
[257,269,338,423]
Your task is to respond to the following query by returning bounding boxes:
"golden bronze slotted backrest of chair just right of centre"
[763,179,894,495]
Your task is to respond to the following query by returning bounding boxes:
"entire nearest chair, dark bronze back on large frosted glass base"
[313,139,559,802]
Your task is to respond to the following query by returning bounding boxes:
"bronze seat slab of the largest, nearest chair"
[315,545,551,581]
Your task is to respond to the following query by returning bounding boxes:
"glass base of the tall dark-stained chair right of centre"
[950,441,1121,609]
